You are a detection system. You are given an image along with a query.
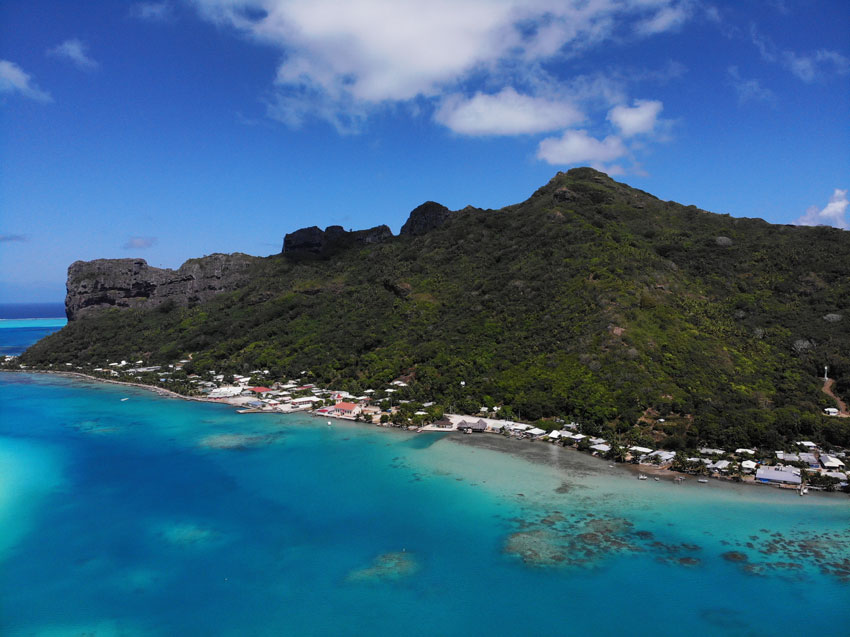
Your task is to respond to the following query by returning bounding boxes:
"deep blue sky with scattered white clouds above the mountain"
[0,0,850,302]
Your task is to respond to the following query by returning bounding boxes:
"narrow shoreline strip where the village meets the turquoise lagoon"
[0,369,845,496]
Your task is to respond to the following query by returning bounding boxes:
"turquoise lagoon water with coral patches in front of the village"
[0,317,850,637]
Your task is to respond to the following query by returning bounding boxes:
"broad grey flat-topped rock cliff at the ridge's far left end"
[65,253,258,321]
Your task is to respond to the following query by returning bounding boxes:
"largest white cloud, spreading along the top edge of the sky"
[194,0,690,120]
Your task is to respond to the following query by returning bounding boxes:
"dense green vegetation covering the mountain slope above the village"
[22,168,850,449]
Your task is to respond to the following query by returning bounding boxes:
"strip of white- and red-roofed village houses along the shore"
[5,357,850,495]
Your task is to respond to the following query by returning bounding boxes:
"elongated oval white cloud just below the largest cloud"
[434,87,584,135]
